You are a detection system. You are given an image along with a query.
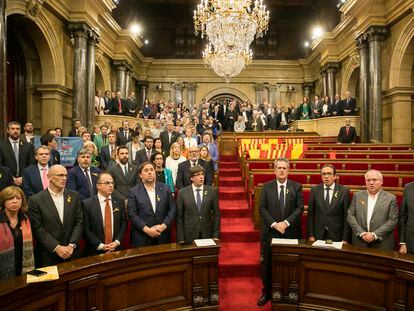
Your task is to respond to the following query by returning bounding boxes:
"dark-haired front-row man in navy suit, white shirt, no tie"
[128,162,176,247]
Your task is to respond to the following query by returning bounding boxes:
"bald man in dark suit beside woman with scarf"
[29,165,83,267]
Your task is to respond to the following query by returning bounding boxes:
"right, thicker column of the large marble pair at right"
[367,26,387,142]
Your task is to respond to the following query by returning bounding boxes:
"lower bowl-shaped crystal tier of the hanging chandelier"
[203,44,252,83]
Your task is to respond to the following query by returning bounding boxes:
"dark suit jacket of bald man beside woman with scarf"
[29,189,83,267]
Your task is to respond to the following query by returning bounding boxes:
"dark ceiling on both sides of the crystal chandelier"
[113,0,340,59]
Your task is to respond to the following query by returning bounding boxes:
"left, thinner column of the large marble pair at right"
[356,34,370,143]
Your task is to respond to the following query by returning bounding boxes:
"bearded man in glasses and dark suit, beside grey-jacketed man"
[307,164,351,243]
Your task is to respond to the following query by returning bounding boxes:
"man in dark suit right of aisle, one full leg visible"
[257,158,303,306]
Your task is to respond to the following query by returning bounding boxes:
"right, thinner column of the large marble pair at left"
[86,30,99,133]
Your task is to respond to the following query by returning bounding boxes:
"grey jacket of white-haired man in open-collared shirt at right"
[347,190,398,250]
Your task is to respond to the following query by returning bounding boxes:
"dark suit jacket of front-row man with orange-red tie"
[82,195,127,256]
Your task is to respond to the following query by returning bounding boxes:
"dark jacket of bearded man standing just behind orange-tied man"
[109,164,141,200]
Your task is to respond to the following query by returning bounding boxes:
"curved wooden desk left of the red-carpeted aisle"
[0,244,220,311]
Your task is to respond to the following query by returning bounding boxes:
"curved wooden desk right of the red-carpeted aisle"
[272,243,414,311]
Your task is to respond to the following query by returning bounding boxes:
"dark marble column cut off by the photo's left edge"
[0,0,7,139]
